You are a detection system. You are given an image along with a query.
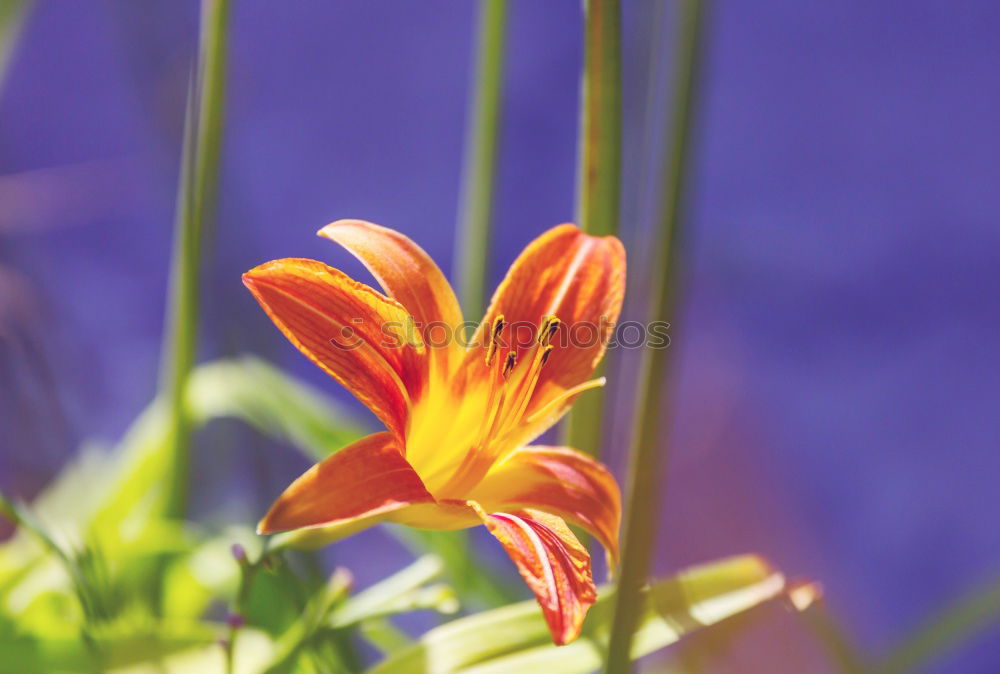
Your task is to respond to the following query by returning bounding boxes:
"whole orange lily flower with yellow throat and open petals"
[243,220,625,644]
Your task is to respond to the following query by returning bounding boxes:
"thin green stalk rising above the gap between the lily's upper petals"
[454,0,507,320]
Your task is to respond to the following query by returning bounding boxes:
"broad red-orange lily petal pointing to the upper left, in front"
[243,258,426,438]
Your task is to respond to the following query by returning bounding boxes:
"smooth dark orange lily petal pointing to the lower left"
[257,432,434,534]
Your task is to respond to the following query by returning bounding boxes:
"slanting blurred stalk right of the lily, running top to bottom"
[607,0,704,674]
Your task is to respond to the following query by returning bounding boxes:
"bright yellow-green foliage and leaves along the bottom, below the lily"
[0,359,804,672]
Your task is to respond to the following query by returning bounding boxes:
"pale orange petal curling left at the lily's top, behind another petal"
[319,220,462,368]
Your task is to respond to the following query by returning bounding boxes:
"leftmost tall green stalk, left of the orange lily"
[160,0,229,517]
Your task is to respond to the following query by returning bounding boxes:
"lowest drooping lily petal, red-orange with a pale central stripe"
[470,502,597,646]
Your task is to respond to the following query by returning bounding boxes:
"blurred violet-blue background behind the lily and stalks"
[0,0,1000,674]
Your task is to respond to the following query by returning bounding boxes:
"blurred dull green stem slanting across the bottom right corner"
[875,578,1000,674]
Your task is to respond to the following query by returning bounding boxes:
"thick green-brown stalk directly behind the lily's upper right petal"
[566,0,622,456]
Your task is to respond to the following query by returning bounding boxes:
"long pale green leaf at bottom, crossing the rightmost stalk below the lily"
[372,555,785,674]
